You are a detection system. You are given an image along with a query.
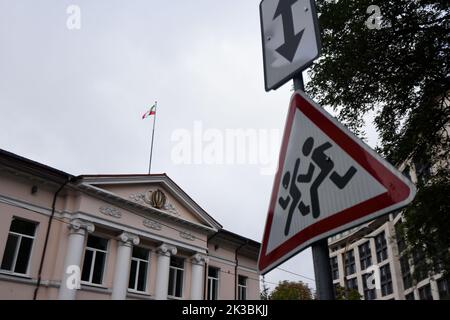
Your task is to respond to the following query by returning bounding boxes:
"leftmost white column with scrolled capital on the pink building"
[58,219,95,300]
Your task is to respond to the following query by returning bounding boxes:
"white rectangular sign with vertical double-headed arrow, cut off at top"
[259,0,320,91]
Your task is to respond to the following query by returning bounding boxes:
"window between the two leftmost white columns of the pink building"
[81,235,108,284]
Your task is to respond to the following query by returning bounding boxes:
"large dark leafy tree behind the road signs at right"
[306,0,450,275]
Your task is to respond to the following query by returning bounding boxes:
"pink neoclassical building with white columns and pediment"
[0,150,260,300]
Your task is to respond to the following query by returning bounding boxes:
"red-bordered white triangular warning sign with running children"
[258,91,415,273]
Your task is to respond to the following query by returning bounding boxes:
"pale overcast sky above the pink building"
[0,0,380,287]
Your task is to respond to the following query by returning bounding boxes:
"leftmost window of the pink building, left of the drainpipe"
[1,218,36,274]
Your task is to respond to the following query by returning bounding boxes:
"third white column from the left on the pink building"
[155,243,177,300]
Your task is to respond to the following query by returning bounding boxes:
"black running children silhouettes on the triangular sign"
[278,137,357,235]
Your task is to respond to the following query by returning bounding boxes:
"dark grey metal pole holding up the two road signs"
[294,73,334,300]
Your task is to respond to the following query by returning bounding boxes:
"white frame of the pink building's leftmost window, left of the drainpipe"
[0,216,39,278]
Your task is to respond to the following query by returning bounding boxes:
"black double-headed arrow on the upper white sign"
[273,0,305,62]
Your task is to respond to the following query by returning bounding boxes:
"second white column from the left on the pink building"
[111,232,139,300]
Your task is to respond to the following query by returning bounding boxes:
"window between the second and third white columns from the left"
[128,247,149,292]
